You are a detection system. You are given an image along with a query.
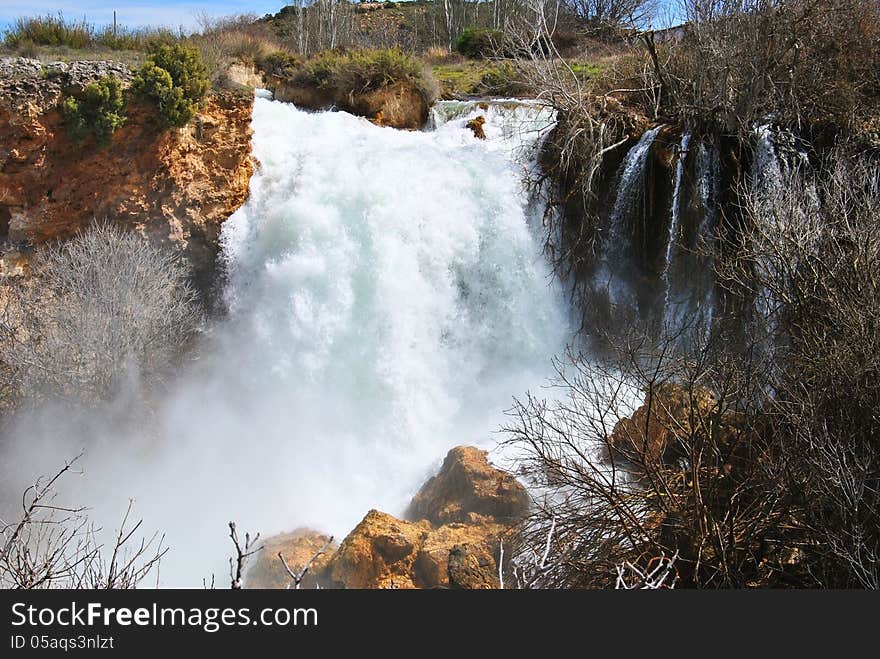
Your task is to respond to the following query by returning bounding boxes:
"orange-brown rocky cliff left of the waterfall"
[0,58,253,290]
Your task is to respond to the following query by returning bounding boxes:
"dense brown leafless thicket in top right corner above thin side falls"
[645,0,880,135]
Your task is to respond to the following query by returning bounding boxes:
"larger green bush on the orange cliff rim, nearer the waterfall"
[133,44,210,127]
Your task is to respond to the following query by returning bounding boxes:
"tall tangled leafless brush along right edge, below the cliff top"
[722,150,880,588]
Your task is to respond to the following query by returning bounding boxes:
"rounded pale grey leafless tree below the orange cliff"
[0,222,201,403]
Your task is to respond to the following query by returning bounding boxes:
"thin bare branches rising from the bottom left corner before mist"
[0,456,167,589]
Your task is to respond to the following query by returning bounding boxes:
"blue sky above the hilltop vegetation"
[0,0,675,31]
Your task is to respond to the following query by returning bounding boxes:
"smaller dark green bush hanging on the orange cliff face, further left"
[61,75,125,146]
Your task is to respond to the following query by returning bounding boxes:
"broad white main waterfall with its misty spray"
[0,98,574,586]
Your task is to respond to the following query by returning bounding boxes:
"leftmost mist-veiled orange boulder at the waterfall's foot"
[245,528,336,588]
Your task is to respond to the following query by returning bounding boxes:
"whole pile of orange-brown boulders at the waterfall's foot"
[246,446,529,589]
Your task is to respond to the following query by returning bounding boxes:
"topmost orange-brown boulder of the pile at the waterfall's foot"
[405,446,529,526]
